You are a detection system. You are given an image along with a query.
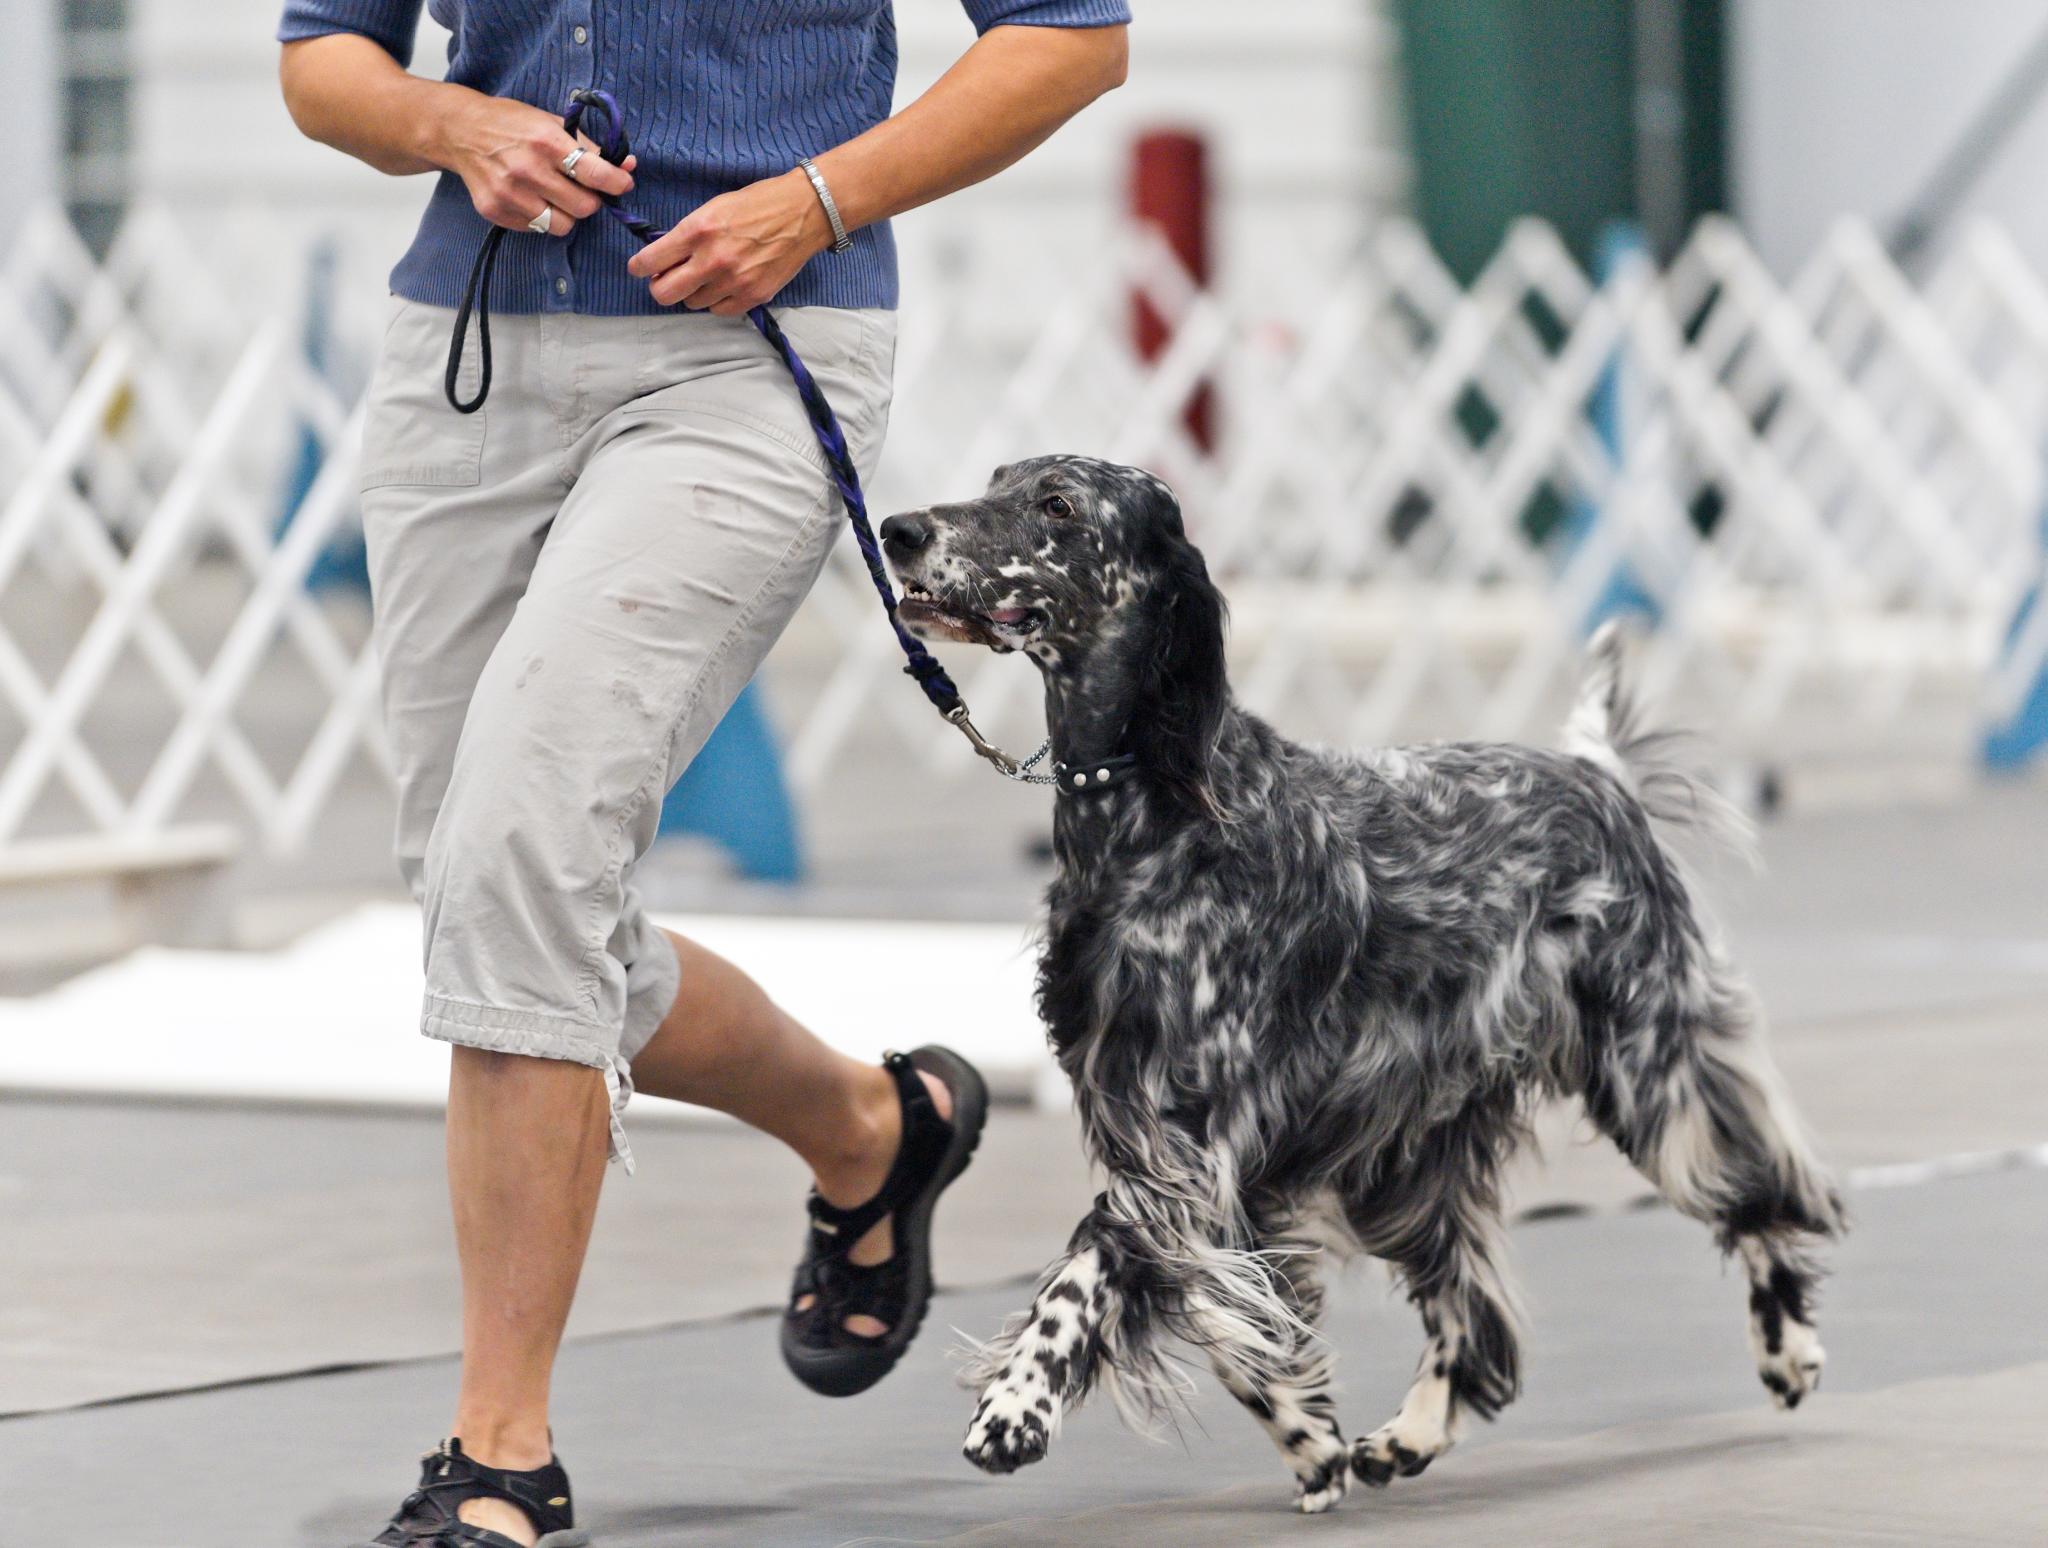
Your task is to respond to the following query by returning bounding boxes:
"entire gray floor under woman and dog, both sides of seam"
[0,782,2048,1548]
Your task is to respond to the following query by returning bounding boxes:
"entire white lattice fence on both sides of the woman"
[0,199,2048,848]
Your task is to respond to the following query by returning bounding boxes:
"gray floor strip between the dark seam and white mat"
[0,999,2048,1416]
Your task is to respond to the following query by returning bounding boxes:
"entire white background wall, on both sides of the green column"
[48,0,2048,311]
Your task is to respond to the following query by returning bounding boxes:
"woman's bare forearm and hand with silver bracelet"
[627,27,1126,317]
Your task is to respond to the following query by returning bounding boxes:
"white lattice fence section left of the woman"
[0,199,383,850]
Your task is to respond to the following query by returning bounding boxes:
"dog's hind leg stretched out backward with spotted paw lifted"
[1587,971,1843,1409]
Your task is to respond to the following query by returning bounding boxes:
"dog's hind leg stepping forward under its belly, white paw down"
[1350,1104,1522,1489]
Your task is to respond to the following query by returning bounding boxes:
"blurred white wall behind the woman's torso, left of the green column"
[119,0,1405,323]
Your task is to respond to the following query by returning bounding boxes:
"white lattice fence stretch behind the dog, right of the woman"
[797,221,2048,774]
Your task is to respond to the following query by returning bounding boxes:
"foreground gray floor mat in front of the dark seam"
[0,1171,2048,1548]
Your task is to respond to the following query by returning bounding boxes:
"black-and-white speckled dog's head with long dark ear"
[881,457,1227,807]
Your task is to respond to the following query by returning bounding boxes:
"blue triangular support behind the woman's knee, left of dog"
[662,682,803,883]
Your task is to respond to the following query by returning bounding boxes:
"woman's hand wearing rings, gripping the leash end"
[436,88,633,238]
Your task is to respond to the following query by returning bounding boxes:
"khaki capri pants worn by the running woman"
[360,299,895,1169]
